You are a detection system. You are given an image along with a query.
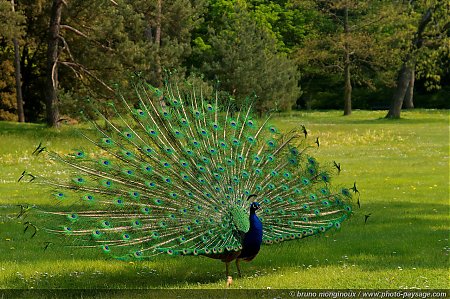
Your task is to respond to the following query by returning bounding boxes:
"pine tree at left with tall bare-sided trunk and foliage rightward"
[42,0,142,126]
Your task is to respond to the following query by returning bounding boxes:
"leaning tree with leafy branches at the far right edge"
[386,0,450,118]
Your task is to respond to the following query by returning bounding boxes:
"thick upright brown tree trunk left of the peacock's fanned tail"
[45,0,63,127]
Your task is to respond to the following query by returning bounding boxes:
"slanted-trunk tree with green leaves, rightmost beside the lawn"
[386,1,450,118]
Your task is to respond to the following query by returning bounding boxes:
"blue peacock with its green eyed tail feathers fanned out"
[20,82,356,277]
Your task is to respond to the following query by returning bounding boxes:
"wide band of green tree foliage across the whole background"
[0,0,450,121]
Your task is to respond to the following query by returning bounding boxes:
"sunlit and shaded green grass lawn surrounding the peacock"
[0,110,450,289]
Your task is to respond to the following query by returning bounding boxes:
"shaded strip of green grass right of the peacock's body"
[256,202,449,271]
